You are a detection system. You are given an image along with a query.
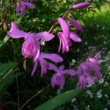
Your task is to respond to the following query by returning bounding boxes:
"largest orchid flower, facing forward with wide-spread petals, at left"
[7,22,54,62]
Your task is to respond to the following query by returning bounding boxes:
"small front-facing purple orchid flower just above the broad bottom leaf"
[48,63,77,89]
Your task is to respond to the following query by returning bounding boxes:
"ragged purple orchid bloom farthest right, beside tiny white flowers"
[77,51,102,89]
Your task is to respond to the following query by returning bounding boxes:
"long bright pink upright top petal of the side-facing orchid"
[58,18,70,38]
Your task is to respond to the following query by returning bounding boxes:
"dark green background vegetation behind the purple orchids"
[0,0,110,110]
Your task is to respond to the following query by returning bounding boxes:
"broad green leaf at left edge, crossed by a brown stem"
[0,62,21,98]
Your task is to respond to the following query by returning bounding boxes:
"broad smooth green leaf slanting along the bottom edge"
[34,90,80,110]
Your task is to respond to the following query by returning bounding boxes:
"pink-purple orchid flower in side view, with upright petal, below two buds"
[58,18,81,53]
